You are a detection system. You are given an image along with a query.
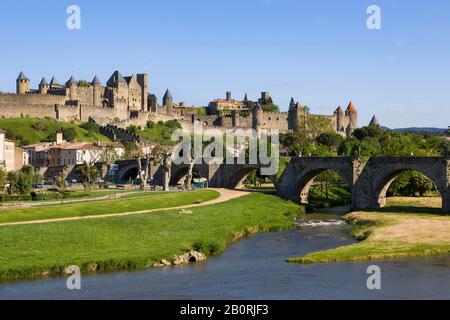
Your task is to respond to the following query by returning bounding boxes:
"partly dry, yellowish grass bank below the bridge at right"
[289,198,450,263]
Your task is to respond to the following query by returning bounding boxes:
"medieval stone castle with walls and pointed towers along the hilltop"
[0,71,358,136]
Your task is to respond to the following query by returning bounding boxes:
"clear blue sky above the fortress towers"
[0,0,450,127]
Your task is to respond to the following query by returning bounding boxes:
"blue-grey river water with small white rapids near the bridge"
[0,215,450,300]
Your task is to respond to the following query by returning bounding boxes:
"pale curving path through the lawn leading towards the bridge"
[0,189,250,227]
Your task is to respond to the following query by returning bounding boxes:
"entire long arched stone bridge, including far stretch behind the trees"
[116,157,450,213]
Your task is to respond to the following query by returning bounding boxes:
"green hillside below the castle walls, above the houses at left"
[0,118,109,146]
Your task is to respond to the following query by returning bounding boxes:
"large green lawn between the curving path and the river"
[0,193,301,280]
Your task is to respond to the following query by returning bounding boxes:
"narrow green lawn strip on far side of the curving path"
[0,190,219,223]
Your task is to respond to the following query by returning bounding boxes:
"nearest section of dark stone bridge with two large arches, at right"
[277,157,450,213]
